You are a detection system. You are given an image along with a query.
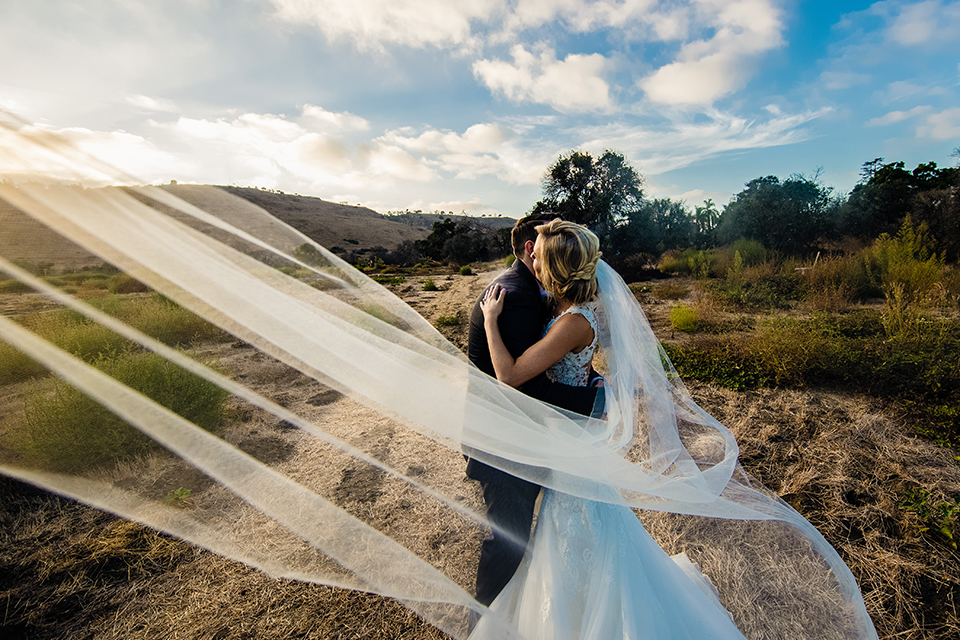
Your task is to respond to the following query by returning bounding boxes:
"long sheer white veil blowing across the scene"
[0,115,877,639]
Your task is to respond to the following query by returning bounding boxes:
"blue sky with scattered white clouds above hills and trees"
[0,0,960,216]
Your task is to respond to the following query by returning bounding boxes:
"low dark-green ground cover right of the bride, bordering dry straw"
[665,310,960,448]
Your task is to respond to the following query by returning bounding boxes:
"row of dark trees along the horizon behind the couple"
[407,150,960,270]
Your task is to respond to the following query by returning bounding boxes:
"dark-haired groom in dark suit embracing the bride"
[467,214,602,605]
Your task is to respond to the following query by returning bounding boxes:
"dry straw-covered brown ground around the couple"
[0,270,960,640]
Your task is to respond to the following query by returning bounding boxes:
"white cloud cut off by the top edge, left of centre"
[271,0,502,50]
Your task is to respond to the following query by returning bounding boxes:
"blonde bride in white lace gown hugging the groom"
[474,220,743,640]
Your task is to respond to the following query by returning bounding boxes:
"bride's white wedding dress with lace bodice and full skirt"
[471,305,744,640]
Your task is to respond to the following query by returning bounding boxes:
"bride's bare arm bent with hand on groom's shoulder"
[480,286,593,387]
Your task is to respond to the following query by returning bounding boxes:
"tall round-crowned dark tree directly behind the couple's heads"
[533,149,643,244]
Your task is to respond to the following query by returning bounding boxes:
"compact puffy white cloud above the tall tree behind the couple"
[473,45,612,112]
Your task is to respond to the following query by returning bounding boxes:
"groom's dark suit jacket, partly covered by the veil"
[467,260,597,481]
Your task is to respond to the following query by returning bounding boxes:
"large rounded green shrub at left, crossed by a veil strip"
[10,351,229,471]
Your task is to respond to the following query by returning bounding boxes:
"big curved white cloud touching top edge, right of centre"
[639,0,783,106]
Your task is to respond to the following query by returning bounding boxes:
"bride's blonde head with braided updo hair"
[537,220,600,304]
